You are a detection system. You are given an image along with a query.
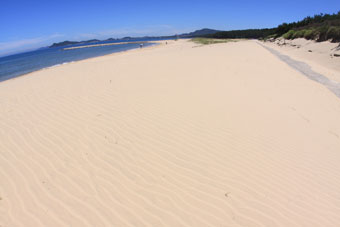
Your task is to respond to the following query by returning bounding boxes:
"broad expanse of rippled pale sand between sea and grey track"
[0,40,340,227]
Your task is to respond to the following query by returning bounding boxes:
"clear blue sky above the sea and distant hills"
[0,0,340,56]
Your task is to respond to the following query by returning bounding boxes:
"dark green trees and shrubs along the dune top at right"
[205,11,340,42]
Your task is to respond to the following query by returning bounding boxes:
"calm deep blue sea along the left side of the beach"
[0,39,166,81]
